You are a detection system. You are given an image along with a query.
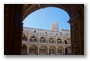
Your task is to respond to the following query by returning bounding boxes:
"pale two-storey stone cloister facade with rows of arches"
[22,21,71,55]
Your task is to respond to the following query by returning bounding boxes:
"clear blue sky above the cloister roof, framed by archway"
[23,7,70,30]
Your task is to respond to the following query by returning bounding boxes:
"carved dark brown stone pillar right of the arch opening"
[69,11,84,55]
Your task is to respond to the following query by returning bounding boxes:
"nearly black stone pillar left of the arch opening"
[4,4,23,55]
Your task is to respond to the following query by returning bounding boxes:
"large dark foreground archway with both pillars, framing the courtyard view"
[4,4,84,55]
